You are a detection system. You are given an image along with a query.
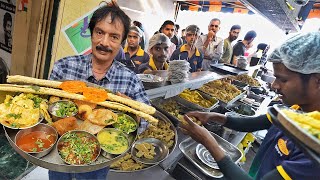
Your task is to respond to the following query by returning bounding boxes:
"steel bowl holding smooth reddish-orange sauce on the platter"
[15,123,58,158]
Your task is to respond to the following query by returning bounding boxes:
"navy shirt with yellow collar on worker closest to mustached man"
[124,46,150,73]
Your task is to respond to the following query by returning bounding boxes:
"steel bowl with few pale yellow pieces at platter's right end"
[131,138,169,164]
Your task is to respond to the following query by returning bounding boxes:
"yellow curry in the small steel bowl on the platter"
[97,128,129,154]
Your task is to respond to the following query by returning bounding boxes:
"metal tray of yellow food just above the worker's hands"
[173,90,219,112]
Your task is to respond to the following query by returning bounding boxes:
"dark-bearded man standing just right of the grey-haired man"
[219,25,241,64]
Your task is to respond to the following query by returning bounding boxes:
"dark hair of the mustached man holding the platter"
[89,3,131,41]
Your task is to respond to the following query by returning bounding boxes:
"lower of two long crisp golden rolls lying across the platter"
[0,84,158,123]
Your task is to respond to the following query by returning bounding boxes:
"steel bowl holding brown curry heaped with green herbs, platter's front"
[56,130,101,166]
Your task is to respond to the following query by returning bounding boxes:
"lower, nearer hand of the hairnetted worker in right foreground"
[179,115,215,144]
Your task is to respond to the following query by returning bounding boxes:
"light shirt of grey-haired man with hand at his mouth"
[195,35,223,62]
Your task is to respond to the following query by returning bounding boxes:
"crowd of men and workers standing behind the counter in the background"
[116,15,267,74]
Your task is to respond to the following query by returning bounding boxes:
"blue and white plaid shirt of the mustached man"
[50,54,150,104]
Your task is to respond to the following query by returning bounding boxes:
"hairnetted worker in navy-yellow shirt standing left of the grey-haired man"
[170,25,203,72]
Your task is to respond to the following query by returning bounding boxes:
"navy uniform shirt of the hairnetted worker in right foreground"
[249,125,320,179]
